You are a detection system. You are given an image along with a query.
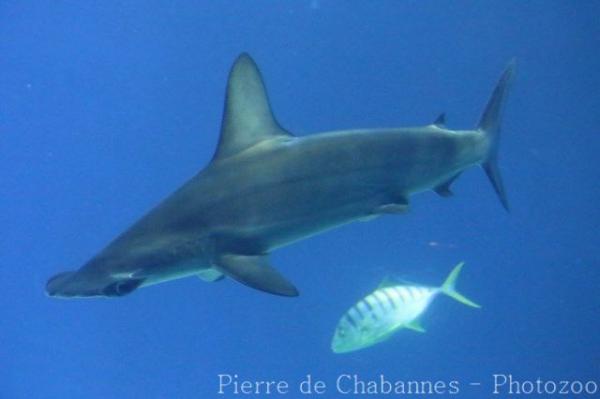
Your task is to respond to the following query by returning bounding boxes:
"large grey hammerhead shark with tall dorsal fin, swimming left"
[46,54,515,297]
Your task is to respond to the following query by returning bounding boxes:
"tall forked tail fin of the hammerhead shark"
[477,59,517,211]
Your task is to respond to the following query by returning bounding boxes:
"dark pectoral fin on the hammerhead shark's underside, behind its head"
[215,254,298,296]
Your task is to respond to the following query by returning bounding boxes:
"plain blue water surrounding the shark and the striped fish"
[0,1,600,399]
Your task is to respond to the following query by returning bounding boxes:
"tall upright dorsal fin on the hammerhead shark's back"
[213,53,292,160]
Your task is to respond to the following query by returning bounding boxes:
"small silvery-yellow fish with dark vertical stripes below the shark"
[331,262,480,353]
